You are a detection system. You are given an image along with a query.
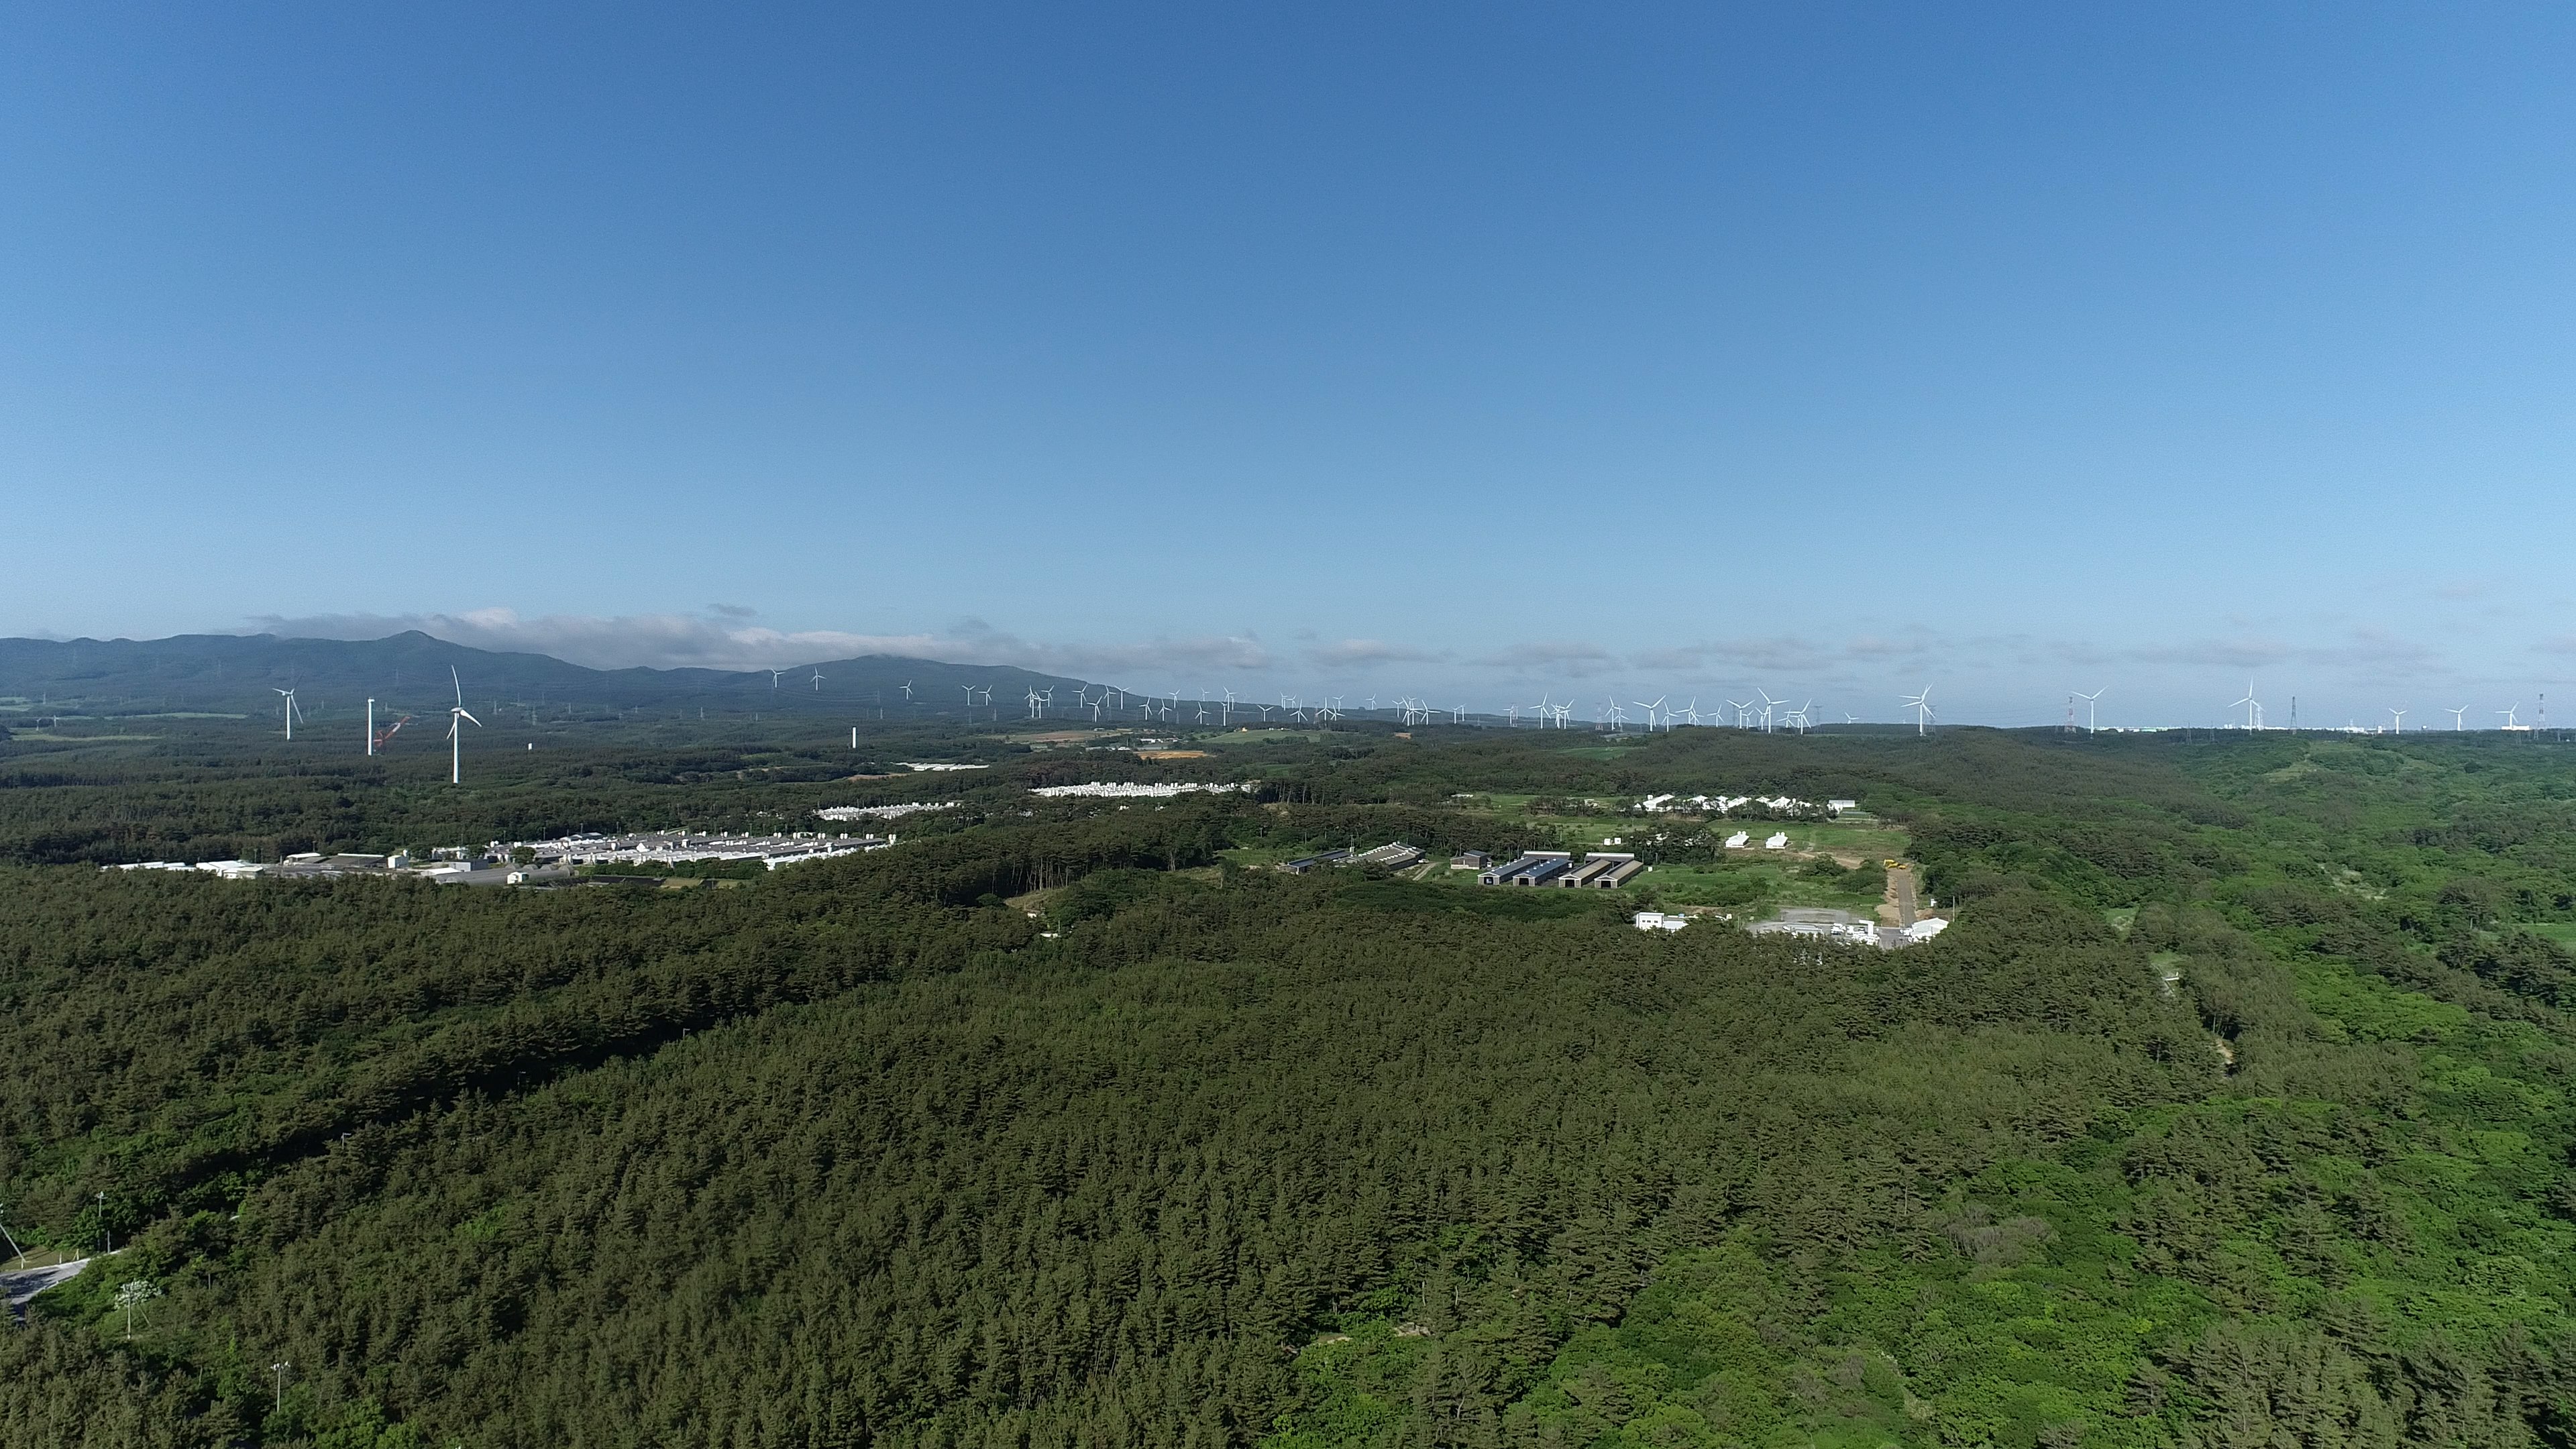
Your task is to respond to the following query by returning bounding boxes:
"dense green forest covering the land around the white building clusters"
[0,727,2576,1449]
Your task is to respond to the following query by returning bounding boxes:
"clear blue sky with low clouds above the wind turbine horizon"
[0,5,2576,724]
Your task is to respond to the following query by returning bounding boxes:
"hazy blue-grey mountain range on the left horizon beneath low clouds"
[0,629,1085,719]
